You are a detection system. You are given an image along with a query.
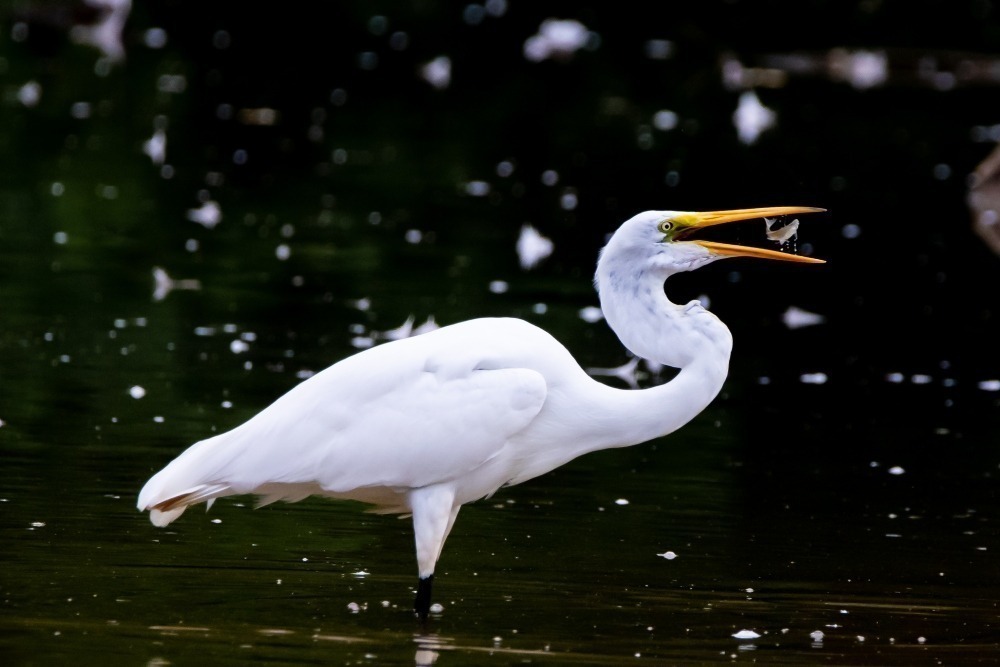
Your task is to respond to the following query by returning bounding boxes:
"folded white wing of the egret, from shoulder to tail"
[139,320,547,521]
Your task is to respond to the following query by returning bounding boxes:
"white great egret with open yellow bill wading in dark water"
[138,206,824,619]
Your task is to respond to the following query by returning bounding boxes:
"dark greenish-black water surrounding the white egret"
[0,2,1000,665]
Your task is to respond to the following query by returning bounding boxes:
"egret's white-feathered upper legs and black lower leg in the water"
[410,486,458,620]
